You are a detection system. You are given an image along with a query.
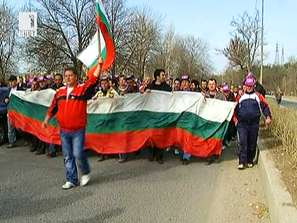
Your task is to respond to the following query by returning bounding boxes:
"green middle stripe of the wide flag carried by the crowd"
[9,95,229,139]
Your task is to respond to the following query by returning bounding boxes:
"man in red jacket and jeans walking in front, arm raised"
[42,58,102,190]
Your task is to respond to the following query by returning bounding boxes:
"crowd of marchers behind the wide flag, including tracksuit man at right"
[5,69,271,169]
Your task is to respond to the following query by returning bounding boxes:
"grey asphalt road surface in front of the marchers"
[0,142,269,223]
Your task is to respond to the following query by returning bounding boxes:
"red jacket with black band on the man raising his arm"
[47,75,97,132]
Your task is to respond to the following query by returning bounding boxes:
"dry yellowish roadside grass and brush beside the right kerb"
[259,99,297,209]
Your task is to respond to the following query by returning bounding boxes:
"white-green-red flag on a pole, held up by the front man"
[78,0,115,73]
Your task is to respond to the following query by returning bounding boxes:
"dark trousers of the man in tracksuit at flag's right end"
[237,123,259,164]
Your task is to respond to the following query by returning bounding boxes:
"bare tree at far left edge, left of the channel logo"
[0,1,17,78]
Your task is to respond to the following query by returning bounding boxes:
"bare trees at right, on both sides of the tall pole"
[217,10,297,96]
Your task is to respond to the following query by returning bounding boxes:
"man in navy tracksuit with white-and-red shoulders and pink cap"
[233,77,271,170]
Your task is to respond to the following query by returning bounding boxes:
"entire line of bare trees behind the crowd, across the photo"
[0,0,297,95]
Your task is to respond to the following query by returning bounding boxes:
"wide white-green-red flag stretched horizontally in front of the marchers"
[8,89,235,157]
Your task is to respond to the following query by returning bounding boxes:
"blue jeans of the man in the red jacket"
[60,129,91,184]
